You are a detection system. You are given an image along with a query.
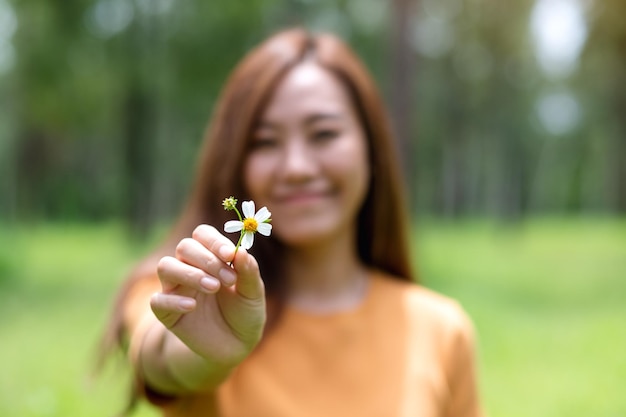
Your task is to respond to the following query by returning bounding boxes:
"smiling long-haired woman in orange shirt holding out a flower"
[102,29,481,417]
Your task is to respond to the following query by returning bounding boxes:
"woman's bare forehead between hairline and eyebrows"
[264,62,353,119]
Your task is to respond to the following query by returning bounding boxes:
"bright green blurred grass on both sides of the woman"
[0,219,626,417]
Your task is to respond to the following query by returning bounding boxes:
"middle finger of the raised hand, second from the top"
[176,238,237,286]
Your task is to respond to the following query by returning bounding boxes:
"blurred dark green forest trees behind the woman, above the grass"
[0,0,626,236]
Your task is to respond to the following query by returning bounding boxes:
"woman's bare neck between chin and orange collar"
[286,234,367,313]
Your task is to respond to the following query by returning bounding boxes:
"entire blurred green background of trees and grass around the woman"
[0,0,626,417]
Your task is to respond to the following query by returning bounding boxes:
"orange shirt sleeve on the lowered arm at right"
[438,307,484,417]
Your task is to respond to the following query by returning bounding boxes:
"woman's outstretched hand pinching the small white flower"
[150,225,266,364]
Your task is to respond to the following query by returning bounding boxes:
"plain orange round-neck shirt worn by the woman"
[127,273,482,417]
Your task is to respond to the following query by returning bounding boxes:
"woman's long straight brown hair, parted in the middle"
[103,28,415,360]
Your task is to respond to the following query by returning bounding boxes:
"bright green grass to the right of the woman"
[418,220,626,417]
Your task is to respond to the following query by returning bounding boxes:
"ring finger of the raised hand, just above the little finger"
[157,256,221,294]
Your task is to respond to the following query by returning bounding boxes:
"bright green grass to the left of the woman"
[0,225,158,417]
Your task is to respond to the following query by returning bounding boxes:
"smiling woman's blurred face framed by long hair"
[244,63,370,246]
